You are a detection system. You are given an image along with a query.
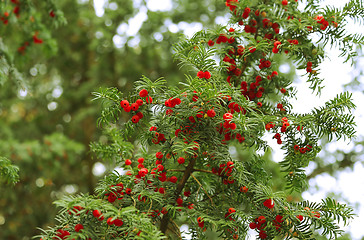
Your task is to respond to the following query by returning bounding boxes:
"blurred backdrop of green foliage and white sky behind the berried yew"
[0,0,364,240]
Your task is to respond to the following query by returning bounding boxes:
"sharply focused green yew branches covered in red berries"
[35,0,364,240]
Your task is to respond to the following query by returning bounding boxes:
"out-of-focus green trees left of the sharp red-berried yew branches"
[0,0,362,240]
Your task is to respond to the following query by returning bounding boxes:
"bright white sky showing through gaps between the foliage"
[94,0,364,240]
